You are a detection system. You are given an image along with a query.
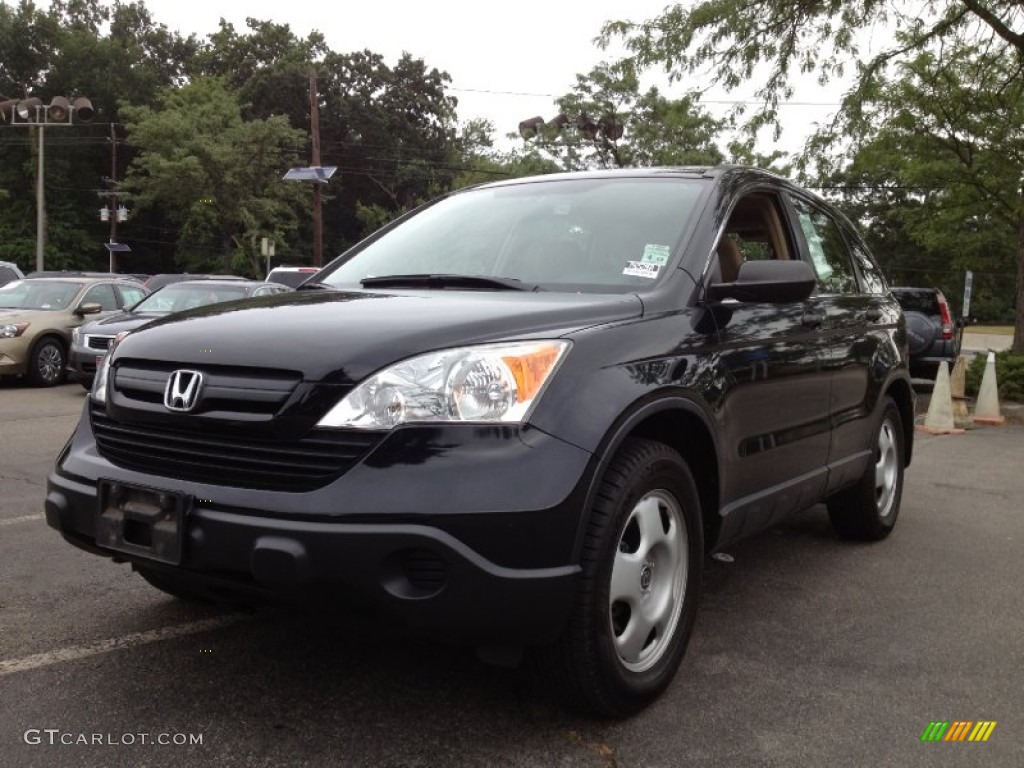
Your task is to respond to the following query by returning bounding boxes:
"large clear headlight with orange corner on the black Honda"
[317,341,569,429]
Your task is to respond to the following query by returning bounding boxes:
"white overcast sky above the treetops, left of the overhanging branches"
[36,0,836,152]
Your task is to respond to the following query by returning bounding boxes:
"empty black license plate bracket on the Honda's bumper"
[95,480,193,565]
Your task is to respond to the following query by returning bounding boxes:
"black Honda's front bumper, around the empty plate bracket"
[45,412,591,644]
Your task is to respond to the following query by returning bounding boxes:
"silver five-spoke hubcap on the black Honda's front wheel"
[608,490,689,672]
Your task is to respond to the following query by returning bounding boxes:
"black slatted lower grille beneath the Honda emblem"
[90,403,383,492]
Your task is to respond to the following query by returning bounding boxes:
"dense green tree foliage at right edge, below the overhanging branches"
[819,47,1024,322]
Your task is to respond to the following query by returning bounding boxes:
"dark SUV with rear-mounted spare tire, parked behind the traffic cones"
[892,287,961,379]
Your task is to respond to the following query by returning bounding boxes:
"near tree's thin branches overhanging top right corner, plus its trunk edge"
[602,0,1024,353]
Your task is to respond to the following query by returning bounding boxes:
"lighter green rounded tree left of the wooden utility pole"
[122,78,305,274]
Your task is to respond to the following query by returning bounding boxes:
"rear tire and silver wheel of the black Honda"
[827,397,905,542]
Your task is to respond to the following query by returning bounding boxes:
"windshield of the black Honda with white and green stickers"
[317,177,705,293]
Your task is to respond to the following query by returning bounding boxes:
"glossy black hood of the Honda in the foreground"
[115,291,643,384]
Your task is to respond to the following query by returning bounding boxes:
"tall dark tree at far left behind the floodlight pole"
[0,0,195,268]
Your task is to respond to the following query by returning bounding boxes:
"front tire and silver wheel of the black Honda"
[538,439,703,717]
